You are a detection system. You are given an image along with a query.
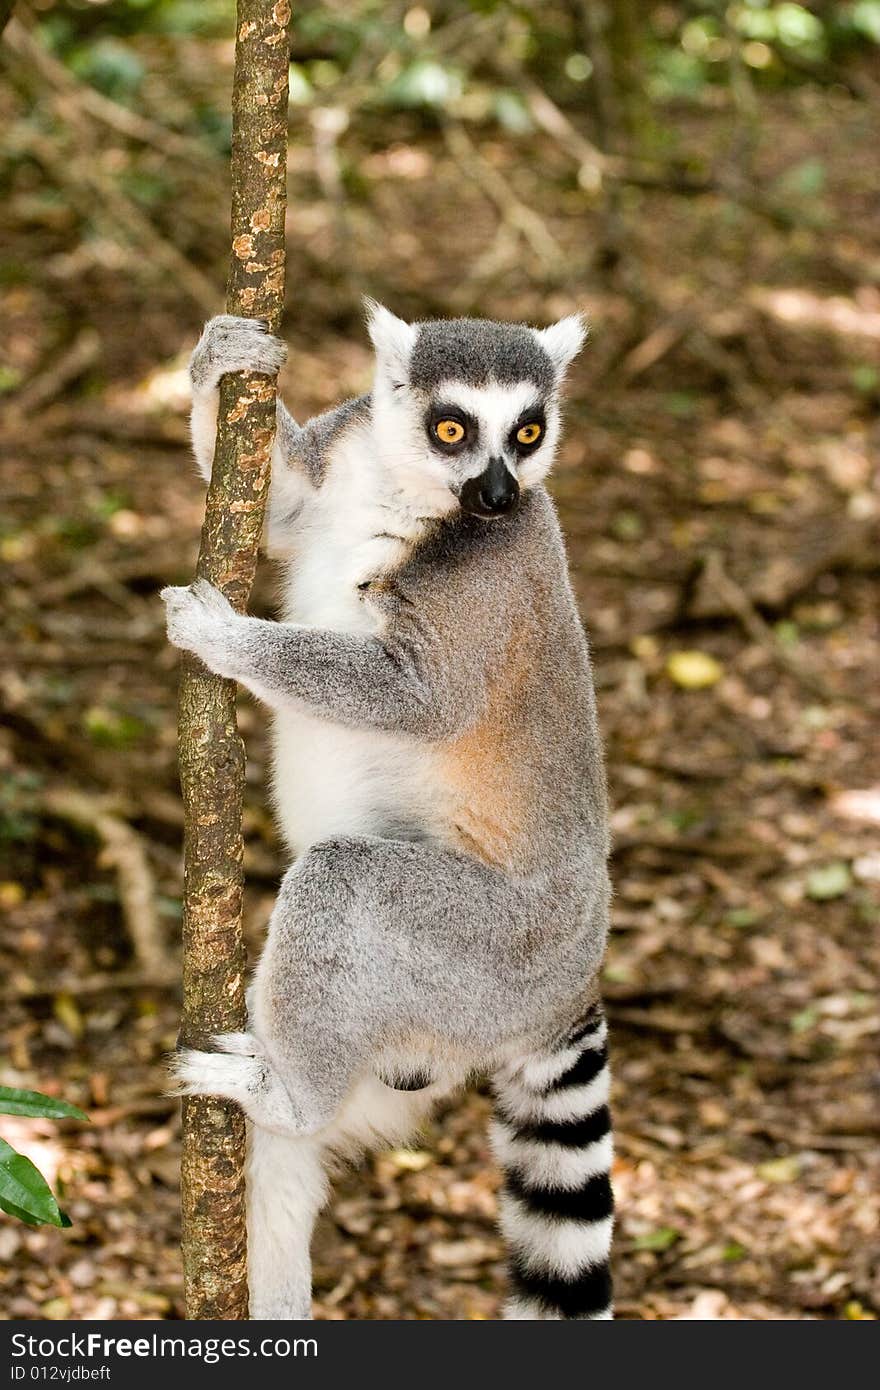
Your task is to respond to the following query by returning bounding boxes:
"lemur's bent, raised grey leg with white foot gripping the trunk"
[179,837,578,1134]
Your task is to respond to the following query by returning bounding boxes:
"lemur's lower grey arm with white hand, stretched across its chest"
[163,580,497,741]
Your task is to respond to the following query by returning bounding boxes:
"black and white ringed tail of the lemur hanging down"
[492,1008,614,1319]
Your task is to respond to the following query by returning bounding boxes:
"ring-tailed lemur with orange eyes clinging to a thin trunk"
[164,304,612,1319]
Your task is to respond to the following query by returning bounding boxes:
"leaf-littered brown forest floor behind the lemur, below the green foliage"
[0,43,880,1319]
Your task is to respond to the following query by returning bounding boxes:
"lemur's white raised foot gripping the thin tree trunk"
[171,1033,320,1138]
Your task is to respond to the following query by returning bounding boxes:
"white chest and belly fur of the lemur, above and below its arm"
[268,431,430,855]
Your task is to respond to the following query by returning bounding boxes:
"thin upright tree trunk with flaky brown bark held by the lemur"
[179,0,291,1319]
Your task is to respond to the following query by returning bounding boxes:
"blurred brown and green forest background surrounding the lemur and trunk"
[0,0,880,1319]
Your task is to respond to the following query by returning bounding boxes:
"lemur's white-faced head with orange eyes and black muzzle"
[367,300,585,520]
